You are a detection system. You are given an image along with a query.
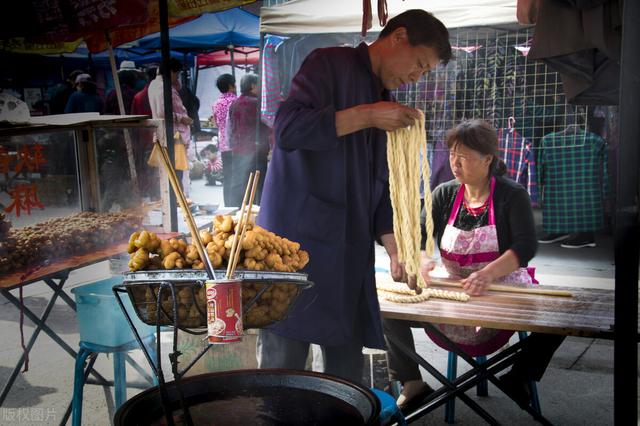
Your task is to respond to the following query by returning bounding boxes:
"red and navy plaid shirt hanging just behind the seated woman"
[498,128,538,207]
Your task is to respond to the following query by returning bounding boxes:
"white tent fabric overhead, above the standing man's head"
[260,0,516,34]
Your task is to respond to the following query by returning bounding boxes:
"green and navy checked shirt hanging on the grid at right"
[538,130,608,234]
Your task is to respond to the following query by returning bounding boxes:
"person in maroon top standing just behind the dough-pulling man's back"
[225,74,271,207]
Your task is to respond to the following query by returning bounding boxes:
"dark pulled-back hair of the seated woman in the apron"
[446,119,507,176]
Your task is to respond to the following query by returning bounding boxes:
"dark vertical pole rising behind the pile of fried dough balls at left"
[158,0,178,231]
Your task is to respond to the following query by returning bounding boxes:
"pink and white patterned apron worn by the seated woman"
[427,178,532,356]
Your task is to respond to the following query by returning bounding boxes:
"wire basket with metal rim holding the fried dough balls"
[123,269,313,330]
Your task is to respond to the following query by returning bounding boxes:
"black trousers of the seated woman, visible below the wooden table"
[382,319,565,383]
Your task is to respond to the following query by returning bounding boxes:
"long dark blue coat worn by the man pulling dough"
[258,43,393,348]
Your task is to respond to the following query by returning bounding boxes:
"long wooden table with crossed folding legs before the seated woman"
[380,285,614,424]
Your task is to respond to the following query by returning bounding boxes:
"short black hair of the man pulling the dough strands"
[378,9,452,64]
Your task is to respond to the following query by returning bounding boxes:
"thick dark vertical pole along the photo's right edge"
[613,1,640,425]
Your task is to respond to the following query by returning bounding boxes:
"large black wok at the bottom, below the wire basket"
[114,370,380,426]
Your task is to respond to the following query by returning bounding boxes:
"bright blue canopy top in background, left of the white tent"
[133,8,260,51]
